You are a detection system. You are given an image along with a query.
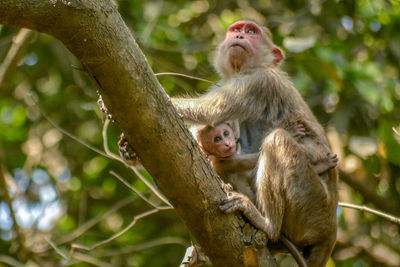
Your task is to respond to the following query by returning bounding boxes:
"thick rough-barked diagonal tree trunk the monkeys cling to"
[0,0,275,266]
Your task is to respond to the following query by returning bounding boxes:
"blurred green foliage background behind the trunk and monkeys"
[0,0,400,266]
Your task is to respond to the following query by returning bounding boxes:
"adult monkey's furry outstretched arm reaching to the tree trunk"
[171,70,279,125]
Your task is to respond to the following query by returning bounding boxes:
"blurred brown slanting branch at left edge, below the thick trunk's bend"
[0,29,36,94]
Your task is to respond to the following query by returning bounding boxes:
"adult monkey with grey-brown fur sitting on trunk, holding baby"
[172,21,338,266]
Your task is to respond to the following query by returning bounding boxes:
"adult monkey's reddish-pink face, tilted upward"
[223,21,262,60]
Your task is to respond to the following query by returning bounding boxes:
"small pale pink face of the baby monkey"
[203,123,236,158]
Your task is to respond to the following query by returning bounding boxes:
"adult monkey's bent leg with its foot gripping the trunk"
[220,129,306,242]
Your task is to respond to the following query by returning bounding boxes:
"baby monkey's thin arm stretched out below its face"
[212,153,260,175]
